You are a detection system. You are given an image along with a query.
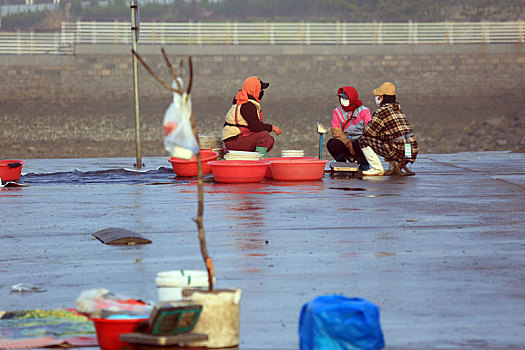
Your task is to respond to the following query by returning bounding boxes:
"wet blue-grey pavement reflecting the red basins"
[0,152,525,350]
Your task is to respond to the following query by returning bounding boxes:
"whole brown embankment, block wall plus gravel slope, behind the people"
[0,44,525,157]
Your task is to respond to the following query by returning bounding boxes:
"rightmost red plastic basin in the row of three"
[270,159,328,181]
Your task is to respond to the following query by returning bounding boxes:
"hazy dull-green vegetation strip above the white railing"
[1,0,525,30]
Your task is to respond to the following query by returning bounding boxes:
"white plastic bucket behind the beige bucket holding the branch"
[155,270,215,303]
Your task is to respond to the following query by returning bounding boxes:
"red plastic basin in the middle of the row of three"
[208,160,268,183]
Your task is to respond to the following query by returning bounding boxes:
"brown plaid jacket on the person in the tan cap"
[359,103,419,161]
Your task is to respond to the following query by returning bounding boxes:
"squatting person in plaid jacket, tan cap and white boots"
[359,82,419,176]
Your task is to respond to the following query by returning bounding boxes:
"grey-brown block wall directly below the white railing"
[0,44,525,100]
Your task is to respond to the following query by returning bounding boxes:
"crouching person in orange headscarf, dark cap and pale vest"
[222,76,283,157]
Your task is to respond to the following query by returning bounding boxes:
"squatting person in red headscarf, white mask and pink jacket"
[326,86,372,170]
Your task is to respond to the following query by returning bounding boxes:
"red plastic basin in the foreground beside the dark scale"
[91,318,148,350]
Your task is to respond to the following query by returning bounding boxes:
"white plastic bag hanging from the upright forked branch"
[163,78,199,159]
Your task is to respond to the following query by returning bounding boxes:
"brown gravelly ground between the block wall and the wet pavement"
[0,94,525,159]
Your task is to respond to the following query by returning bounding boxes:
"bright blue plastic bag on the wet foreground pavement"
[299,295,385,350]
